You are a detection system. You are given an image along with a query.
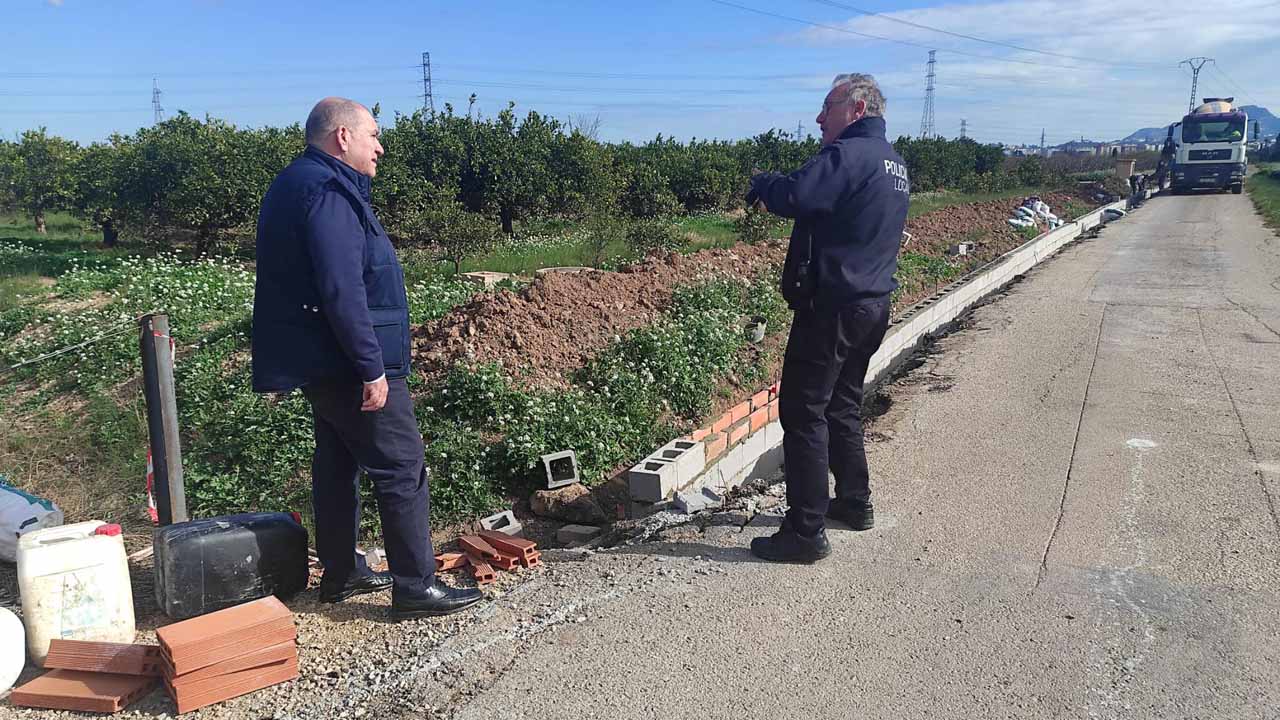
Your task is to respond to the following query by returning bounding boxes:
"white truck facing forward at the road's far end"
[1170,97,1249,193]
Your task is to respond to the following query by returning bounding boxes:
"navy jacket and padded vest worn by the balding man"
[253,146,410,392]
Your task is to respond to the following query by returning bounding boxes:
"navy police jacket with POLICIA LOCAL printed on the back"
[751,118,910,310]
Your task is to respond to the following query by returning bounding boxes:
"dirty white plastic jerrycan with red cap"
[18,520,134,666]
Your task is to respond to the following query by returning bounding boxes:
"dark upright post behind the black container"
[138,315,188,525]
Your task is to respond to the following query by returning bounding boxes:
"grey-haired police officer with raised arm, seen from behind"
[748,73,910,562]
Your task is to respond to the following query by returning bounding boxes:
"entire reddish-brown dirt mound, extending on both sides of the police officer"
[413,193,1100,388]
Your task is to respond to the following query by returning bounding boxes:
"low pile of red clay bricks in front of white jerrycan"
[9,639,160,712]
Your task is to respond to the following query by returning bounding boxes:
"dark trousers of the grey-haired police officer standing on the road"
[778,297,890,536]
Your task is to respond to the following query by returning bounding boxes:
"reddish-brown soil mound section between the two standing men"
[413,242,786,387]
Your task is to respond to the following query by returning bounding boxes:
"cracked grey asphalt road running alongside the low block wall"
[432,195,1280,720]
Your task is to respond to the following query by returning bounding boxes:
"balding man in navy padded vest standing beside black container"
[253,97,483,618]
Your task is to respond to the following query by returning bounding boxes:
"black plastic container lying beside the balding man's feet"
[155,512,307,620]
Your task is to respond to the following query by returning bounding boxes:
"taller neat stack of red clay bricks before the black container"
[156,597,298,714]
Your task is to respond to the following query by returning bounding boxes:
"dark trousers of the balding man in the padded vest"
[302,378,435,596]
